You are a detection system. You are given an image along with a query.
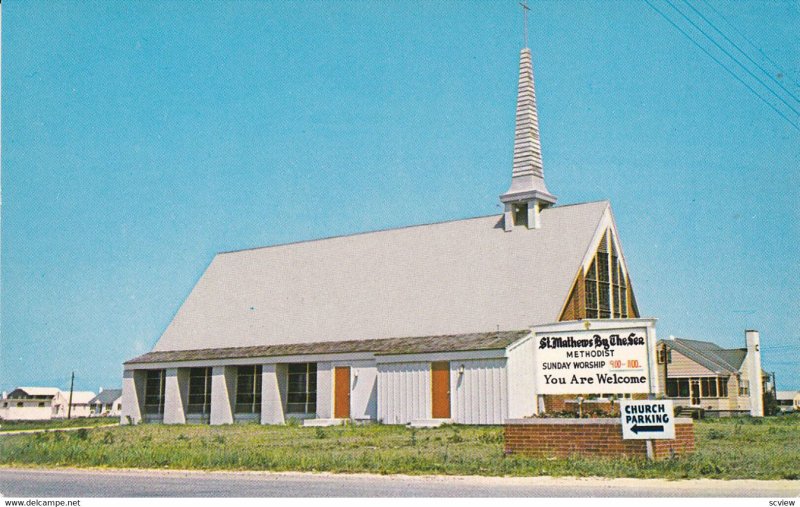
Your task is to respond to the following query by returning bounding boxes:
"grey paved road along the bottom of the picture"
[0,468,800,498]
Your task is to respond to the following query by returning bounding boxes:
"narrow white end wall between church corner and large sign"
[507,338,539,419]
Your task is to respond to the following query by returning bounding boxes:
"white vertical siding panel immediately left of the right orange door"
[378,362,432,424]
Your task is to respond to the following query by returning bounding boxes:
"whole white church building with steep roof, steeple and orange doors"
[122,42,644,425]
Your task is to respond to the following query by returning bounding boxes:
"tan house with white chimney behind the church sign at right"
[657,330,769,416]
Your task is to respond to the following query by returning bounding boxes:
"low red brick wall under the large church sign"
[504,418,694,459]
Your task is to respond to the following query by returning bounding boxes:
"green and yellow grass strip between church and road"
[0,416,800,480]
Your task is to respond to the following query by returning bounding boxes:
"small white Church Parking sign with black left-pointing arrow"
[619,400,675,440]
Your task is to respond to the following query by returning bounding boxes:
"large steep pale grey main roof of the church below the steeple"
[153,201,613,352]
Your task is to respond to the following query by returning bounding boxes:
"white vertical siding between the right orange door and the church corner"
[450,359,508,424]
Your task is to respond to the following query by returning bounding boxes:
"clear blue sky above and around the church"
[0,0,800,390]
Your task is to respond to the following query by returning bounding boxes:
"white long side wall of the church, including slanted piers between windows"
[123,347,516,424]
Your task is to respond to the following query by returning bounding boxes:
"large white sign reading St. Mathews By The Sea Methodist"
[535,327,650,394]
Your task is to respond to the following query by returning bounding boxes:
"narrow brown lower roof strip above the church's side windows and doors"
[125,329,531,364]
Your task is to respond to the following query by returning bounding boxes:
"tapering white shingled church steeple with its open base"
[500,47,556,231]
